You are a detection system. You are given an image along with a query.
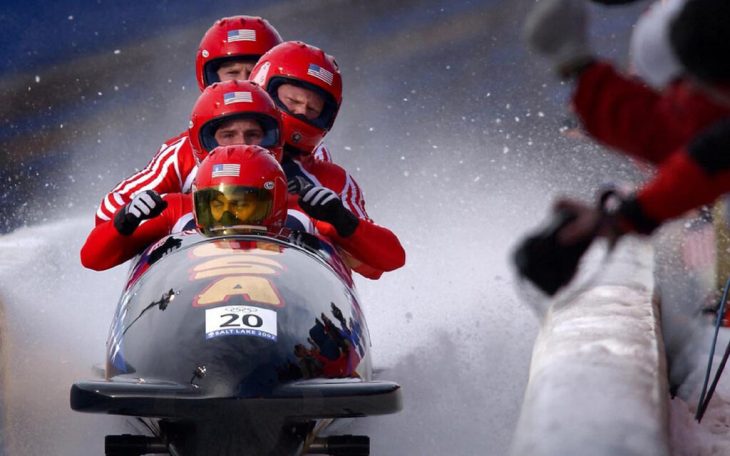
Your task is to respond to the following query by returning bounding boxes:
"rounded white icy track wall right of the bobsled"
[512,238,669,456]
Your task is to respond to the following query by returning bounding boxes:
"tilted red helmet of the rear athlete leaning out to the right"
[250,41,342,154]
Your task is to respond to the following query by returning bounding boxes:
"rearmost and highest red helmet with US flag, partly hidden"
[195,16,281,91]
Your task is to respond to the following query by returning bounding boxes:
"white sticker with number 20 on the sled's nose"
[205,306,276,341]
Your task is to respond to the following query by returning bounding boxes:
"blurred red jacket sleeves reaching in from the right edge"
[573,62,730,232]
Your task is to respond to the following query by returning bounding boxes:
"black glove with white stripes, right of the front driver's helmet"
[289,176,360,237]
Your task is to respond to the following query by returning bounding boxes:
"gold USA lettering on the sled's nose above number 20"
[190,244,284,307]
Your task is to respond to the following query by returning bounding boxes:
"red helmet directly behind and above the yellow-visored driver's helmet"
[188,81,283,162]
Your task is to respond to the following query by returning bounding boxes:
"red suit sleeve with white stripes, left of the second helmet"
[96,131,332,225]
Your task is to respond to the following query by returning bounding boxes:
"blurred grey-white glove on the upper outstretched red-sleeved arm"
[523,0,593,78]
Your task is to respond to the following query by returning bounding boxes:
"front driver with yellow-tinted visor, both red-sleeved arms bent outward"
[81,145,402,277]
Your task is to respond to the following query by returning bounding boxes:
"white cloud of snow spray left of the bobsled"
[0,219,130,455]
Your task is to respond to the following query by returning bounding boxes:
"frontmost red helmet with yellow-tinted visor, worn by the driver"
[192,145,287,236]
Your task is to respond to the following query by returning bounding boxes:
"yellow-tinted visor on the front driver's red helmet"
[194,184,274,235]
